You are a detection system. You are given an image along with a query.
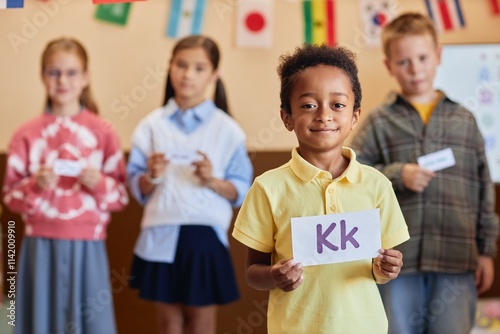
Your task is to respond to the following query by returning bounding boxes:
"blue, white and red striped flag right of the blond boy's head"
[425,0,465,31]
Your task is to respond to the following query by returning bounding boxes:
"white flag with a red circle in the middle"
[236,0,274,48]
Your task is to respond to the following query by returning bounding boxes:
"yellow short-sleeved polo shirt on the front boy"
[233,147,409,334]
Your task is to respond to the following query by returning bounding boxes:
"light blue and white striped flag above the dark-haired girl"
[167,0,206,38]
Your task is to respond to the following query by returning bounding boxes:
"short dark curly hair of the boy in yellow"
[278,44,361,114]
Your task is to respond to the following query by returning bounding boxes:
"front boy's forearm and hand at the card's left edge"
[247,248,303,292]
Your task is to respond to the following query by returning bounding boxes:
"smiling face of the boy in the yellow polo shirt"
[281,65,361,155]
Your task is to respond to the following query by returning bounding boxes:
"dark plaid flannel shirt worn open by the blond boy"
[352,92,499,274]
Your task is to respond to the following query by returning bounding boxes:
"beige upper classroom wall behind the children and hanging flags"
[0,0,500,152]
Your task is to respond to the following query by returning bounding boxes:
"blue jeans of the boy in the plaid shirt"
[379,273,477,334]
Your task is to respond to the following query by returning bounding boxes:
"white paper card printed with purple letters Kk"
[291,209,382,266]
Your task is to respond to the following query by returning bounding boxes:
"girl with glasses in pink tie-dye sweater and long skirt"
[3,38,128,334]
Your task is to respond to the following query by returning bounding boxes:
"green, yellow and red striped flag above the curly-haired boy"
[302,0,336,45]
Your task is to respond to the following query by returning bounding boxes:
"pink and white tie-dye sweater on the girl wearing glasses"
[3,110,128,240]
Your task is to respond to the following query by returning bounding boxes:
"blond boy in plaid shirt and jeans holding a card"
[352,13,498,334]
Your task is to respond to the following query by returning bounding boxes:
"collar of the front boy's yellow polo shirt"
[290,146,361,183]
